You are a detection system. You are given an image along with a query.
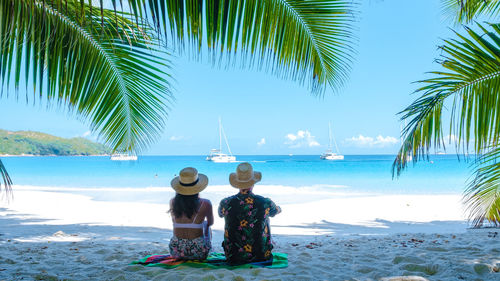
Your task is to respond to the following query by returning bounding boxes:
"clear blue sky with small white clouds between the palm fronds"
[0,0,460,155]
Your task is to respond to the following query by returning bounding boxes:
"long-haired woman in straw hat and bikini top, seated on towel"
[169,165,214,260]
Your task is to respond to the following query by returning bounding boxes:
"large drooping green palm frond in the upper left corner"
[0,0,172,151]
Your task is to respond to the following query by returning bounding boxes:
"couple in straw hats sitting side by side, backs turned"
[169,163,281,264]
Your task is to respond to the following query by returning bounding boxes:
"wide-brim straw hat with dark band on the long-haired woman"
[170,167,208,195]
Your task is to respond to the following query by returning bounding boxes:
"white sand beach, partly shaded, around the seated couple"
[0,186,500,280]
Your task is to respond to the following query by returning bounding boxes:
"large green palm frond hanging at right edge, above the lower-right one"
[393,24,500,175]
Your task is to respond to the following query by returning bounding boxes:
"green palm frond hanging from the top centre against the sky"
[117,0,357,94]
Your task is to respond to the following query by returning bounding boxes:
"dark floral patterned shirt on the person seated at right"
[219,191,278,264]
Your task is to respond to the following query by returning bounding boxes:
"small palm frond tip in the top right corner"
[442,0,500,23]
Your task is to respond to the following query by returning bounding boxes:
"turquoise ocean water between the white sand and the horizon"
[2,155,471,194]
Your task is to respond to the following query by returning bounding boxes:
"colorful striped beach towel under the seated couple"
[132,250,288,268]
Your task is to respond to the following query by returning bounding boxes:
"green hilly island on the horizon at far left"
[0,130,110,156]
